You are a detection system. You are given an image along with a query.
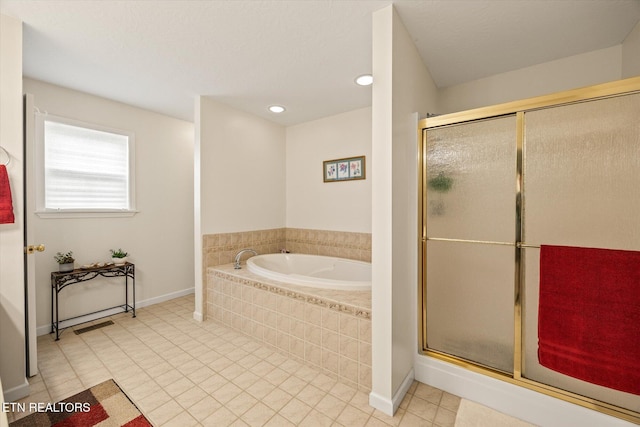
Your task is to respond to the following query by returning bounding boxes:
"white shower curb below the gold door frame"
[414,355,633,427]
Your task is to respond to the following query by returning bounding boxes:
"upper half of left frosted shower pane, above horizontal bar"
[427,116,516,243]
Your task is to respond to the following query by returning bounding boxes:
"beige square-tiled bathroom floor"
[9,295,460,427]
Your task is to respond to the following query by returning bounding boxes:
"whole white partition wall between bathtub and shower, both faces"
[370,6,437,414]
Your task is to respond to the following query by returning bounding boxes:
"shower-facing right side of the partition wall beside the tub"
[392,2,438,393]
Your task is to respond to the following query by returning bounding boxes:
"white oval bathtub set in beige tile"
[247,254,371,291]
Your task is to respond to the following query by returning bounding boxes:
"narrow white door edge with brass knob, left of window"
[23,94,45,377]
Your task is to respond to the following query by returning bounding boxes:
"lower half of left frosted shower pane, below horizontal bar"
[427,241,515,373]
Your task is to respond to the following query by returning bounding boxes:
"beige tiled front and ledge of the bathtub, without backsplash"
[207,265,371,392]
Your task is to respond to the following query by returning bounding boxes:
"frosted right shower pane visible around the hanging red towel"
[522,94,640,411]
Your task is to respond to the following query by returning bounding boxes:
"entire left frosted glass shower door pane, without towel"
[424,116,517,372]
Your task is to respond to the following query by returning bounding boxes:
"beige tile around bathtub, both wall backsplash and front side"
[202,228,371,391]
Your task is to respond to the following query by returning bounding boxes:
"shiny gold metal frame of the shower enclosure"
[418,77,640,424]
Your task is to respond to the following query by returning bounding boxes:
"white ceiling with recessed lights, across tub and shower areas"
[0,0,640,126]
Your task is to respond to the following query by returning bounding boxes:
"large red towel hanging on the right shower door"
[538,246,640,394]
